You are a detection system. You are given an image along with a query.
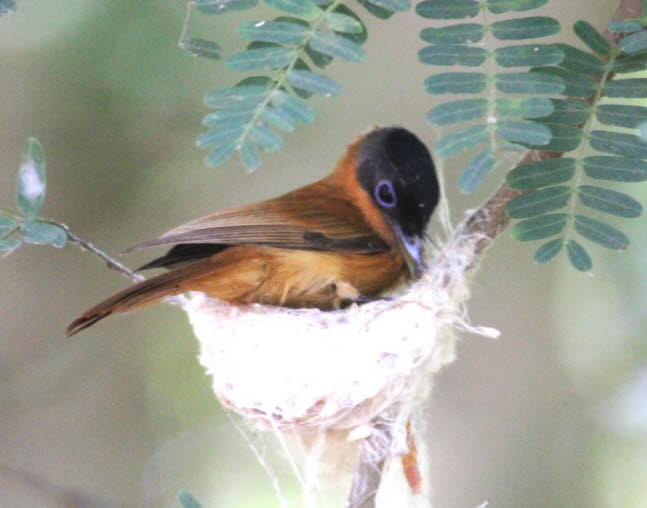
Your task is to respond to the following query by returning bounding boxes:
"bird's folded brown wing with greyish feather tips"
[129,180,388,253]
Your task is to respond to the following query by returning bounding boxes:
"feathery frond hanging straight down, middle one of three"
[416,0,564,193]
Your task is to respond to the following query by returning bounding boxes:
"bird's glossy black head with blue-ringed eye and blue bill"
[357,127,440,275]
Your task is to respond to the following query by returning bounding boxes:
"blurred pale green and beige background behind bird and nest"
[0,0,647,508]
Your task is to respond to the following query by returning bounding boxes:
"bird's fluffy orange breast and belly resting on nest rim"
[183,246,406,309]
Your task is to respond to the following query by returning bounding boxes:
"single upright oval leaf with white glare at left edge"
[16,138,46,217]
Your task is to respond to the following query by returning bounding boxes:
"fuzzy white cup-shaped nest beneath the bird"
[185,232,498,439]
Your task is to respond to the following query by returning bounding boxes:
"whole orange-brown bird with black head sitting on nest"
[67,126,440,336]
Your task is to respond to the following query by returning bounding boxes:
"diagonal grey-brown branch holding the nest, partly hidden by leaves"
[346,0,643,508]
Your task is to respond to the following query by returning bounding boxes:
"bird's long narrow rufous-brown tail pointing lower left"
[66,260,218,337]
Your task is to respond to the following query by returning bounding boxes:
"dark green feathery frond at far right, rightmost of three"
[506,21,647,271]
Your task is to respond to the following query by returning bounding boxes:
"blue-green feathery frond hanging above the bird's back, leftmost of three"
[190,0,410,170]
